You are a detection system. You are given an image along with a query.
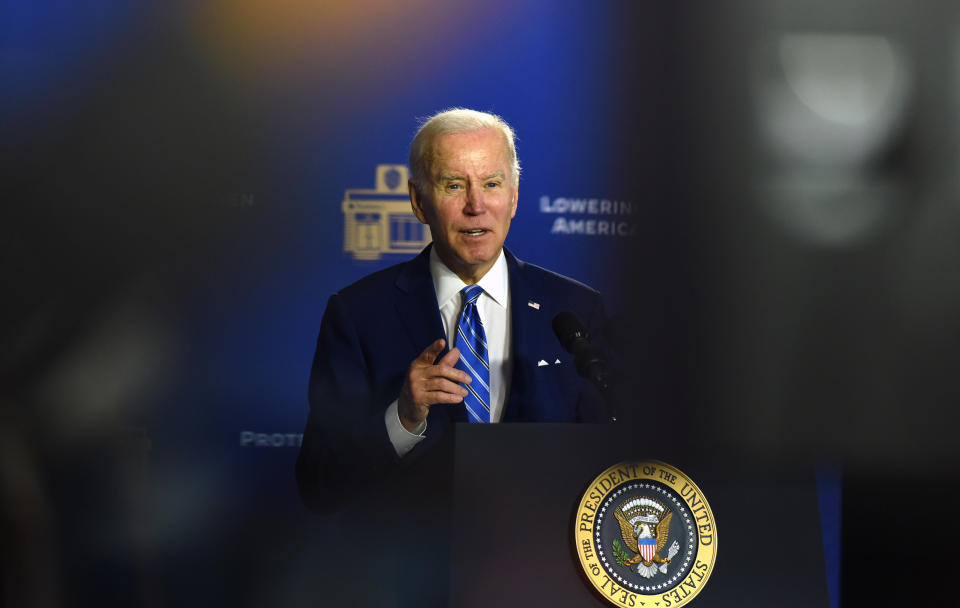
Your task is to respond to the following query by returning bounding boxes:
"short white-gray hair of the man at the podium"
[410,108,520,192]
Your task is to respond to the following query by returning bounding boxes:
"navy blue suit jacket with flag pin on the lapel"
[297,247,604,510]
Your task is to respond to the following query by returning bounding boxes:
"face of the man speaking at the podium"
[410,129,518,284]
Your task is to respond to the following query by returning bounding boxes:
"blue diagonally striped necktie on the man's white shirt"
[454,285,490,422]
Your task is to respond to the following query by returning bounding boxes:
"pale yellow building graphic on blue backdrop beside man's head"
[342,165,430,260]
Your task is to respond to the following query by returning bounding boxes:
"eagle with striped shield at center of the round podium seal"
[613,497,680,578]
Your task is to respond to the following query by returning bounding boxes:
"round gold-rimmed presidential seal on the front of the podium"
[573,461,717,608]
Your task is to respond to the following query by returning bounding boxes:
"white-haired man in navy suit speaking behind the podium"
[296,109,605,511]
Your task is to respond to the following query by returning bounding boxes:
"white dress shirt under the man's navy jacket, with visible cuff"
[385,248,513,456]
